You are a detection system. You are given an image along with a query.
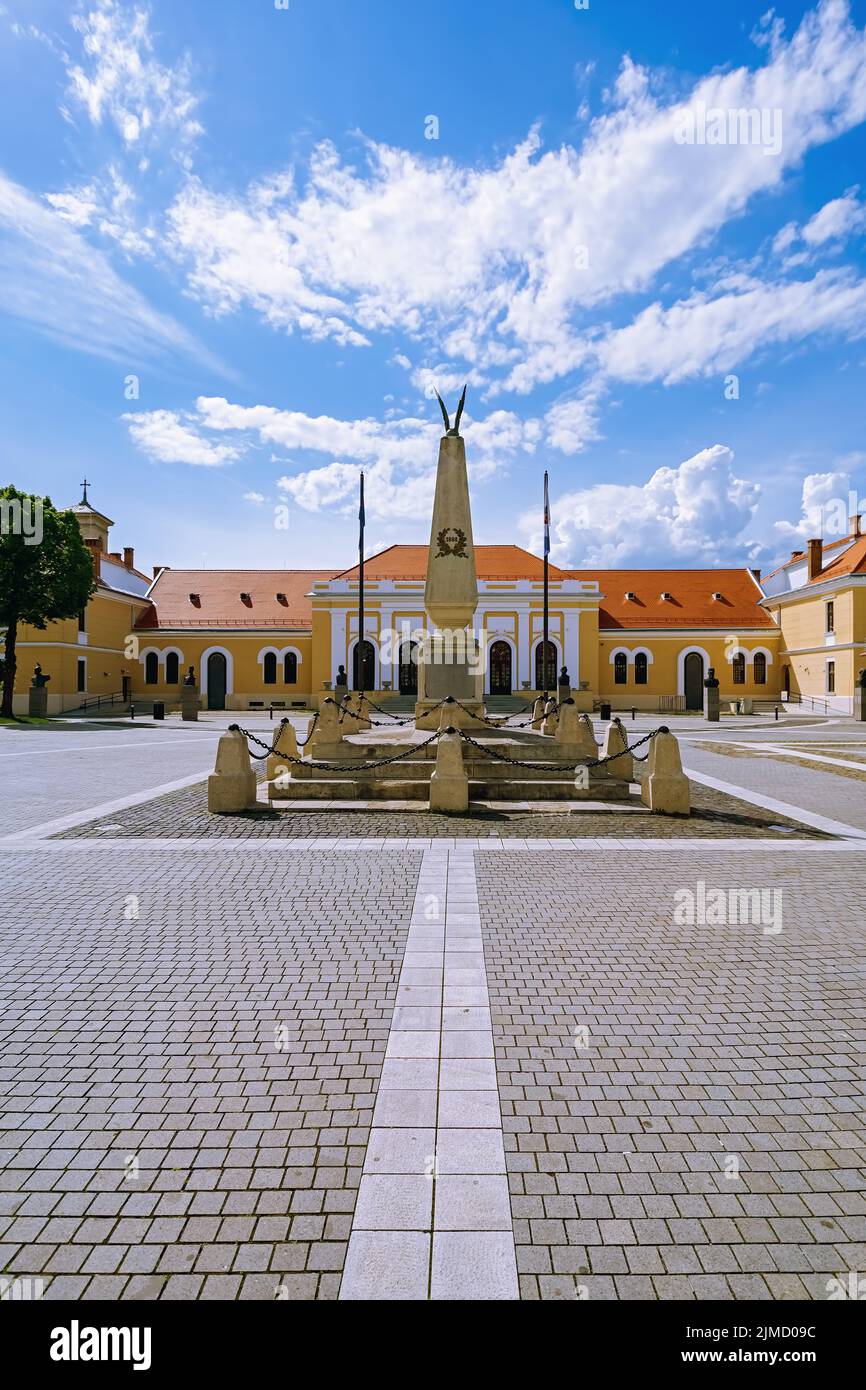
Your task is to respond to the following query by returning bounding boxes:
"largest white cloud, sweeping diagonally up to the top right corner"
[161,0,866,392]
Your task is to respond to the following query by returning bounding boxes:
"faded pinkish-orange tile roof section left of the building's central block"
[135,570,334,628]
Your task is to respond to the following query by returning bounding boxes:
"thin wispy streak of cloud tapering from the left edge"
[0,174,216,373]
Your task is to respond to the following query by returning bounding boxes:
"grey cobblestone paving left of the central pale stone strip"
[0,845,421,1298]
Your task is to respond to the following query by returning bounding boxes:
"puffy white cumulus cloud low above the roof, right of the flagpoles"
[521,445,760,569]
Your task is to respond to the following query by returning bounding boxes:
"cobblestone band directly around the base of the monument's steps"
[57,783,823,840]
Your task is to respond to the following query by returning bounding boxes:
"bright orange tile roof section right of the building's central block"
[567,570,776,632]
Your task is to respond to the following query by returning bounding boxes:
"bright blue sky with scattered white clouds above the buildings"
[0,0,866,567]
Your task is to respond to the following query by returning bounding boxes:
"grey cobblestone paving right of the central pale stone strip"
[475,847,866,1298]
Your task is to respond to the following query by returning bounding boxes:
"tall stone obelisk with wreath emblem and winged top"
[416,389,484,728]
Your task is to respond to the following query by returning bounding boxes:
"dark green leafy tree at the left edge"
[0,487,96,719]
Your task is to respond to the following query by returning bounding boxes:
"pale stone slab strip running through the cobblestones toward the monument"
[341,845,518,1300]
